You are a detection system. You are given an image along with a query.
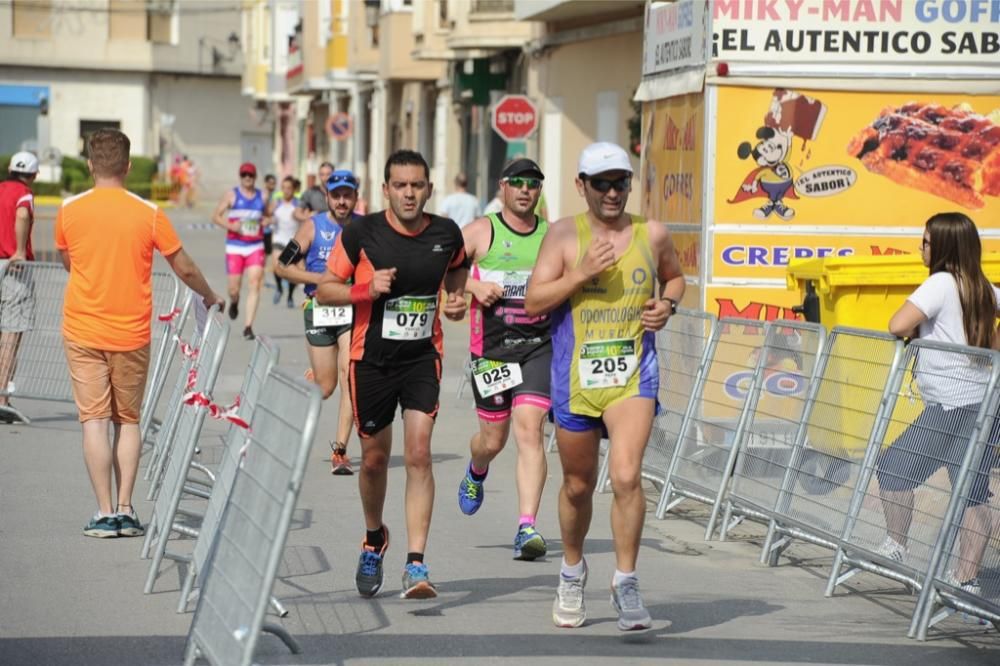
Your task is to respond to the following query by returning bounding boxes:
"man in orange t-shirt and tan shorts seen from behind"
[56,129,223,537]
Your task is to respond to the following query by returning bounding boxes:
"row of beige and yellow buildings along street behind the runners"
[244,0,644,217]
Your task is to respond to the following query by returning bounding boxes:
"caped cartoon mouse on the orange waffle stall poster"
[729,126,799,220]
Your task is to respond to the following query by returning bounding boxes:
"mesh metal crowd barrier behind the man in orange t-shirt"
[0,261,180,422]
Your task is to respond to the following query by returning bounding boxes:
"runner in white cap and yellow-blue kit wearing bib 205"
[525,143,684,631]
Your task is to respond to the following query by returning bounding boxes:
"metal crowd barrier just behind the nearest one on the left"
[177,336,287,616]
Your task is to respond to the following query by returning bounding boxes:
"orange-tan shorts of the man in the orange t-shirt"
[63,340,149,423]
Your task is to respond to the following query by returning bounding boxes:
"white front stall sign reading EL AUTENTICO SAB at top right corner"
[712,0,1000,66]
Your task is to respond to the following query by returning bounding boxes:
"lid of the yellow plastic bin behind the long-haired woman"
[785,252,1000,294]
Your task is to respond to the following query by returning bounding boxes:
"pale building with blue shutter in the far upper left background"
[0,0,270,197]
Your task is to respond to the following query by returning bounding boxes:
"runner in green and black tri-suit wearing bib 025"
[458,159,552,560]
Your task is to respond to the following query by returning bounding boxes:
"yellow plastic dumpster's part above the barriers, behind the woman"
[785,252,1000,331]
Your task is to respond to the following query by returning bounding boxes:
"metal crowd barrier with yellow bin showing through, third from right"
[761,327,903,565]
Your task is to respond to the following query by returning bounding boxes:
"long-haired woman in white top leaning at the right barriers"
[877,213,1000,594]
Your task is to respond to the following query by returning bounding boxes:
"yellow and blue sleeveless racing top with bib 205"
[552,214,659,416]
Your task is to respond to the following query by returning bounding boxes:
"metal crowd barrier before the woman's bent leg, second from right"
[826,340,1000,596]
